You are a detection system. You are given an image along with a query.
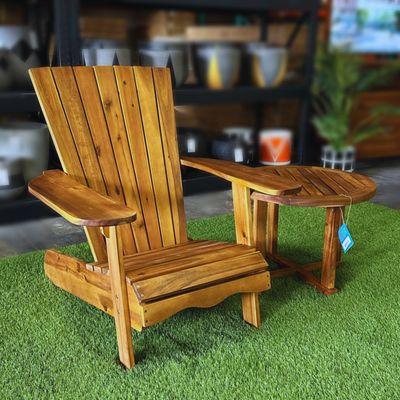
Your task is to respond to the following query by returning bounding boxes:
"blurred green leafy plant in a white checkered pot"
[312,50,400,171]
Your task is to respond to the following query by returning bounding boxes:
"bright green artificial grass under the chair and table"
[0,204,400,400]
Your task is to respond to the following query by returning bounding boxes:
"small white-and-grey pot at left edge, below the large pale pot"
[0,157,25,201]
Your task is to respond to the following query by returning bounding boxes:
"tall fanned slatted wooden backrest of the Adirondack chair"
[30,66,187,261]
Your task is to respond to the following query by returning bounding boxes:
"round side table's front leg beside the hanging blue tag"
[321,207,342,294]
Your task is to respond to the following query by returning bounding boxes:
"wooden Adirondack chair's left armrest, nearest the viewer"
[28,170,136,226]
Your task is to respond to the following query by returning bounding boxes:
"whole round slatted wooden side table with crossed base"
[252,166,376,295]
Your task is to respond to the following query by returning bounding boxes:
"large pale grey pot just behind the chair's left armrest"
[0,122,49,182]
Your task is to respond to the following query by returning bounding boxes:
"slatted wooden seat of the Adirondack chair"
[86,240,267,303]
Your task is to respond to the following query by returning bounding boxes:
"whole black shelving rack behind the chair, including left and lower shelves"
[0,0,319,223]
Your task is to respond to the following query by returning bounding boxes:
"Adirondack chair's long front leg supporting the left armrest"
[103,226,135,368]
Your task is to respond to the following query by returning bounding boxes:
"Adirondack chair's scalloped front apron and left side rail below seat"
[45,250,271,331]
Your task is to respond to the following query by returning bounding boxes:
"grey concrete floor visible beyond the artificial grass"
[0,159,400,258]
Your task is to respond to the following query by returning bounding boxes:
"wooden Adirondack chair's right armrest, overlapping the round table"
[181,157,301,196]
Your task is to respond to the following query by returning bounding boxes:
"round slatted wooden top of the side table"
[252,166,376,207]
